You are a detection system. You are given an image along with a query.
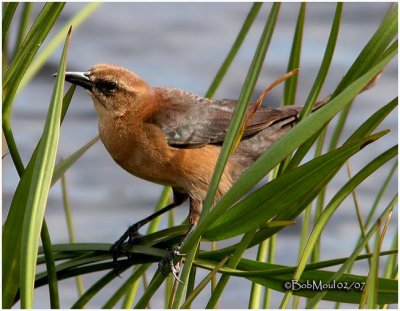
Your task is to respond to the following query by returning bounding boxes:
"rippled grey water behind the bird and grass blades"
[3,3,398,308]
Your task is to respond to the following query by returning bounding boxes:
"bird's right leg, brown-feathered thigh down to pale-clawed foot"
[158,198,202,283]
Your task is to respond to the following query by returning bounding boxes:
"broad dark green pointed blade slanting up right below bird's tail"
[204,133,383,240]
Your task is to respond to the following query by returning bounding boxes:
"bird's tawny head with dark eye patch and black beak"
[65,64,151,115]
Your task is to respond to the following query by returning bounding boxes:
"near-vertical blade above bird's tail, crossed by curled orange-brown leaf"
[283,2,306,106]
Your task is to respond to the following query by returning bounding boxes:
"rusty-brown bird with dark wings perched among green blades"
[65,64,378,280]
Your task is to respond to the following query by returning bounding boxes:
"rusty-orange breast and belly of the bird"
[95,113,236,201]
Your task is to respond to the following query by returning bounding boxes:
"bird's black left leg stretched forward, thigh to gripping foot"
[110,191,188,274]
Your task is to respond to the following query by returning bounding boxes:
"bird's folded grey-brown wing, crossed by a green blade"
[148,88,300,148]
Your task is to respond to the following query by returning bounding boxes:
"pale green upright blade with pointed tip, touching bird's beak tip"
[20,26,71,308]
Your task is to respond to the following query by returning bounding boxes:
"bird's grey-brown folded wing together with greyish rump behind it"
[147,88,302,182]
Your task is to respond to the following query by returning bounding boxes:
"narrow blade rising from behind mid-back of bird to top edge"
[206,2,262,98]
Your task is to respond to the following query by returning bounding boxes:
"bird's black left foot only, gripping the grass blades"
[110,224,141,276]
